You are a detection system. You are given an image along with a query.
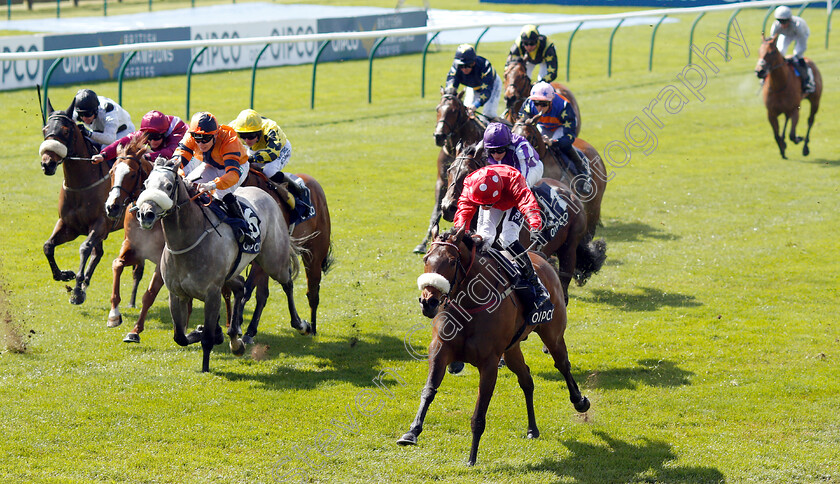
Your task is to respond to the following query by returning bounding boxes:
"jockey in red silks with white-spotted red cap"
[454,165,542,249]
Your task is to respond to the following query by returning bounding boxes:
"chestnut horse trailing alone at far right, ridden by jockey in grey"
[755,34,822,159]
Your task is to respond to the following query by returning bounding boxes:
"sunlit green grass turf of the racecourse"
[0,2,840,483]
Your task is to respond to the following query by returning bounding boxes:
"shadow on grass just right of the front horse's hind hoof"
[536,358,694,390]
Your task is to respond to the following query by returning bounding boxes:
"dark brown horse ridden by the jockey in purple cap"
[441,145,607,296]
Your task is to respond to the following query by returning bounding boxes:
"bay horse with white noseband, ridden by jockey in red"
[397,227,589,465]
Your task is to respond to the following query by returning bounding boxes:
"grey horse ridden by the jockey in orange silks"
[136,158,311,372]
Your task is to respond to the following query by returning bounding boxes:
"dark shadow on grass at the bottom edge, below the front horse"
[500,430,726,483]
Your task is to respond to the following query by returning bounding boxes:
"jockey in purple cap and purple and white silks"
[484,123,543,188]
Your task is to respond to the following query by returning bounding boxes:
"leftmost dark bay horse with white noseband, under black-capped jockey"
[38,99,122,304]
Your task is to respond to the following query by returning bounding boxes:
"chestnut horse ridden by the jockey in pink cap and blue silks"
[512,115,607,242]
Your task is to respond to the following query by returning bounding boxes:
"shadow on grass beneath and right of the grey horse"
[214,329,412,390]
